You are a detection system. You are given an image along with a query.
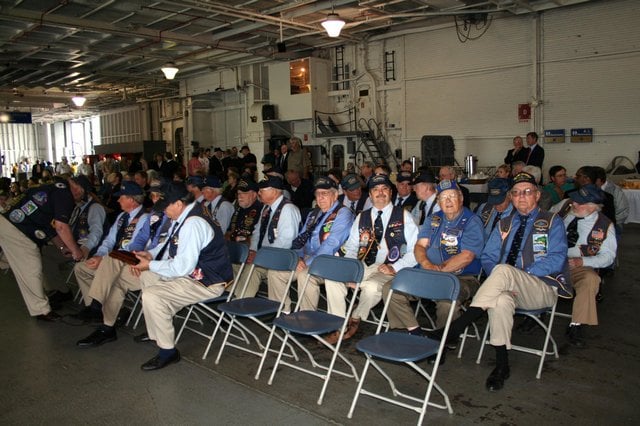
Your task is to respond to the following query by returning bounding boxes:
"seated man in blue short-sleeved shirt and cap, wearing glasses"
[382,180,484,334]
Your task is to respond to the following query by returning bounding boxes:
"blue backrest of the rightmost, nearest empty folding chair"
[391,268,460,300]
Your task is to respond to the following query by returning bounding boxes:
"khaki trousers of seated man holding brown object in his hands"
[140,271,225,349]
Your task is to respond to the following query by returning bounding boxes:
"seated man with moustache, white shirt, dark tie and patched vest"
[325,175,418,339]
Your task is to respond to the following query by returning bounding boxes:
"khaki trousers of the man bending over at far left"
[0,215,51,317]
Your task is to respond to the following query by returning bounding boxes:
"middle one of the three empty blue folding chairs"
[256,255,364,405]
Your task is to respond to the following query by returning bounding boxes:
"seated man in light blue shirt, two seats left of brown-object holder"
[73,181,147,321]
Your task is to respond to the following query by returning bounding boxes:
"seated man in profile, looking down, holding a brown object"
[131,182,233,371]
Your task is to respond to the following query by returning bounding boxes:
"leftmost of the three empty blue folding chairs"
[212,247,298,364]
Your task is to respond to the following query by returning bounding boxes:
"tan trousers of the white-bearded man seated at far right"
[569,266,600,325]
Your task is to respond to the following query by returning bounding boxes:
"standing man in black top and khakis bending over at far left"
[0,176,84,321]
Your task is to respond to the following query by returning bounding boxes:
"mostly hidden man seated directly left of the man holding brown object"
[76,182,171,348]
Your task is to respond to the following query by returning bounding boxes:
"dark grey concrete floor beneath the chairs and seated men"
[0,225,640,425]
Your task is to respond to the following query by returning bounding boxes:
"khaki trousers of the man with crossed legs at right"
[471,264,558,349]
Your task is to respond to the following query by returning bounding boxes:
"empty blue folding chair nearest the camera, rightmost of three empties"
[347,268,460,424]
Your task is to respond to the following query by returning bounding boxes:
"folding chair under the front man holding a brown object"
[176,241,249,359]
